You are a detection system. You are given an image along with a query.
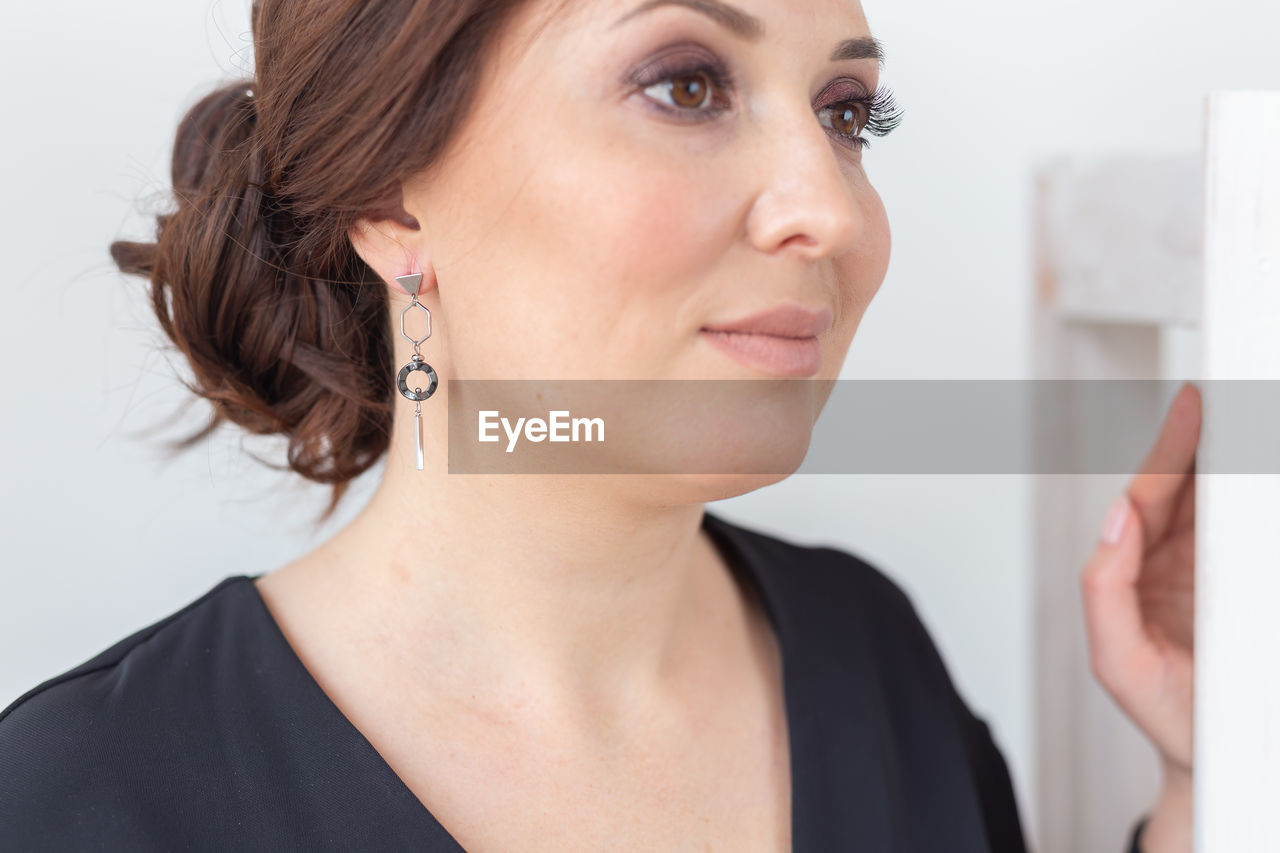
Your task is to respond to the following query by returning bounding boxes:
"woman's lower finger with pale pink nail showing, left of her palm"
[1080,494,1158,703]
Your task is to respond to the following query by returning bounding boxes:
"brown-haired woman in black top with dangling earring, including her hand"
[0,0,1199,853]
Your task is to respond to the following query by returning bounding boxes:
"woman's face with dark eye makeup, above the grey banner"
[396,0,890,479]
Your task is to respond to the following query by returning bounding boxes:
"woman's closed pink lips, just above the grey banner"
[699,302,832,378]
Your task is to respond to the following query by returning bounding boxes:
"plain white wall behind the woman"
[0,0,1280,849]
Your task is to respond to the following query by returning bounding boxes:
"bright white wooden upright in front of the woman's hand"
[1196,92,1280,853]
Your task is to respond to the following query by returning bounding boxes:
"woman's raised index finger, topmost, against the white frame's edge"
[1128,382,1202,542]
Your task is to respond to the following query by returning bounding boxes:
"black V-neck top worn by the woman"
[0,512,1152,853]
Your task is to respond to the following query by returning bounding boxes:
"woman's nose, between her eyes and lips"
[748,99,863,260]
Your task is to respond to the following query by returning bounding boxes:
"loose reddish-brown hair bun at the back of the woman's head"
[111,81,394,516]
